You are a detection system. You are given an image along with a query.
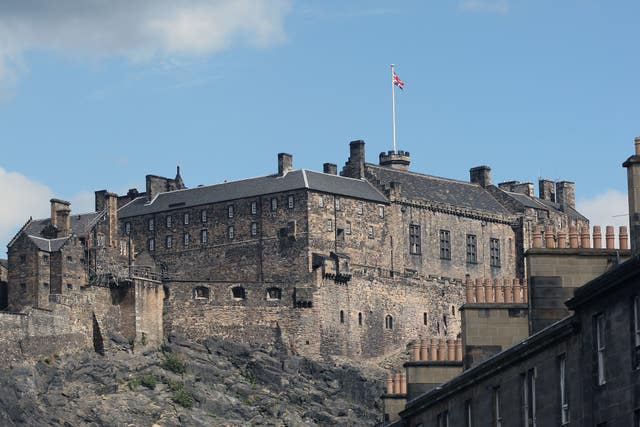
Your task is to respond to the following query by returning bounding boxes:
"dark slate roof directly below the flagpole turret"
[366,164,509,214]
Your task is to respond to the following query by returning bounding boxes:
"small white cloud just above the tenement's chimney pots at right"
[576,190,629,247]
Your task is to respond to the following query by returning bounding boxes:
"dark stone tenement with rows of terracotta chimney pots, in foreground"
[383,138,640,427]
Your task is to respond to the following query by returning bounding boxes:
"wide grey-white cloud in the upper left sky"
[0,0,290,81]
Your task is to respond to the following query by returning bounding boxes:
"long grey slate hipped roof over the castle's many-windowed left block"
[118,169,389,218]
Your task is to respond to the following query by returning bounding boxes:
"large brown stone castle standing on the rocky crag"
[2,141,589,359]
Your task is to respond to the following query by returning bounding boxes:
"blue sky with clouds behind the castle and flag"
[0,0,640,255]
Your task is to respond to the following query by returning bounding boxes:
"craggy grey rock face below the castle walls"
[0,336,382,426]
